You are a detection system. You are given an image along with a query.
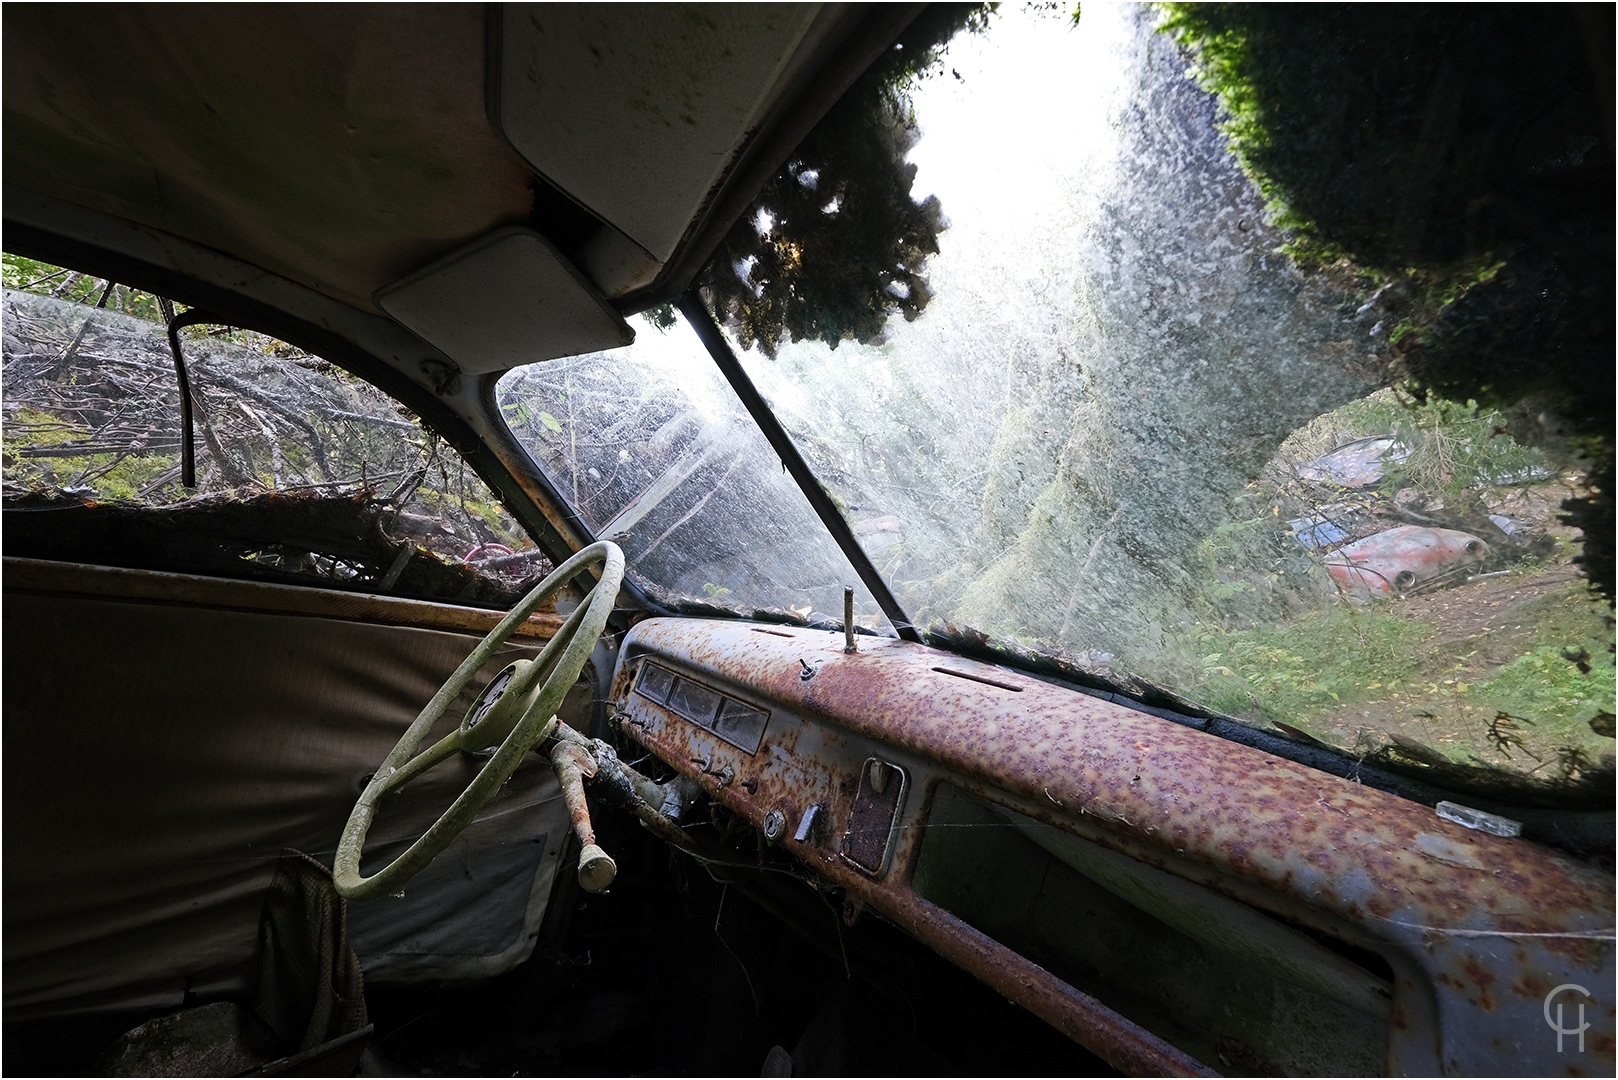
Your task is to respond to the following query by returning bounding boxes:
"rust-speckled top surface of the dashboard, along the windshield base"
[623,619,1613,938]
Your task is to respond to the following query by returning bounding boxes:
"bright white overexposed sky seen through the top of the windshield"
[718,3,1137,415]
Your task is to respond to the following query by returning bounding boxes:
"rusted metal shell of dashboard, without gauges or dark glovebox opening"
[615,619,1615,1074]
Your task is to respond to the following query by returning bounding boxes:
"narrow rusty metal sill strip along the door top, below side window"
[5,557,561,641]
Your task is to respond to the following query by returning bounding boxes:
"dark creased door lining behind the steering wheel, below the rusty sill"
[3,559,576,1018]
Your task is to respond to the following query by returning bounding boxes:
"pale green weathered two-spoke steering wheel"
[332,541,623,900]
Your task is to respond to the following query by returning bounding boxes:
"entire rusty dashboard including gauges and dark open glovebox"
[612,619,1615,1075]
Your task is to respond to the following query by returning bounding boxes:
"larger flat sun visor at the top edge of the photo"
[490,3,827,262]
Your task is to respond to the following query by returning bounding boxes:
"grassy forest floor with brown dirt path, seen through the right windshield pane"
[1191,486,1618,780]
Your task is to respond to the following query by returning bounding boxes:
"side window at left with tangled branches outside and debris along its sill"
[3,254,550,606]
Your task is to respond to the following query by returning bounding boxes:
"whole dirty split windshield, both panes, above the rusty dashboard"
[500,5,1613,780]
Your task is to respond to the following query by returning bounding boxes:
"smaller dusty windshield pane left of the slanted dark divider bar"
[497,317,888,633]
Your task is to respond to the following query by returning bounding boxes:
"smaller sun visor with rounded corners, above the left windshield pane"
[375,227,634,374]
